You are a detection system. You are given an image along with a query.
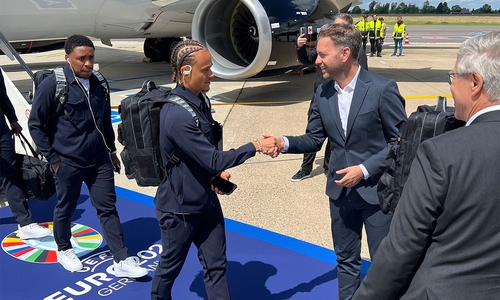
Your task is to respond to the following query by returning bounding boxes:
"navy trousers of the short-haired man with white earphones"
[53,162,128,262]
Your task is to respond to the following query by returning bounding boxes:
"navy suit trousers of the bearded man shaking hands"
[330,189,392,300]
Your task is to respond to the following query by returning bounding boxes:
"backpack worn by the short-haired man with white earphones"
[33,67,109,121]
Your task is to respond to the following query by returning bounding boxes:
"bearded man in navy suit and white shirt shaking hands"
[266,24,406,300]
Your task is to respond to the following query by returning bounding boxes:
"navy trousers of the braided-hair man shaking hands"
[151,202,231,300]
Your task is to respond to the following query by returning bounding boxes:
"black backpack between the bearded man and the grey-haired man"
[377,96,465,214]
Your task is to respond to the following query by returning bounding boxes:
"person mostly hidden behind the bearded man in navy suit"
[292,13,368,182]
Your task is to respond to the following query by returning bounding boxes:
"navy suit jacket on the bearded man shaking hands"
[287,68,406,204]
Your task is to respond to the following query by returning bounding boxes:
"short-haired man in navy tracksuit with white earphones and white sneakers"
[28,35,148,278]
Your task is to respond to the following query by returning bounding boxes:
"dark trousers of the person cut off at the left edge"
[0,126,33,227]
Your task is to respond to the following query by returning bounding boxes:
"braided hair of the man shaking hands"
[170,39,207,82]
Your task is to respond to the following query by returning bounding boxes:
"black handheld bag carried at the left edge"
[16,133,56,201]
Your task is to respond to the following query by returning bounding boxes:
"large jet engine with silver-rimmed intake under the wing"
[191,0,352,80]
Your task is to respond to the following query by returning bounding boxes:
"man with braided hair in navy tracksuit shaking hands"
[151,40,275,300]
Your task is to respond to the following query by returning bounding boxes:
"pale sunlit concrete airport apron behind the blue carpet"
[0,34,459,260]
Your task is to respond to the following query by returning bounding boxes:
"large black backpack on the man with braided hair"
[118,80,199,186]
